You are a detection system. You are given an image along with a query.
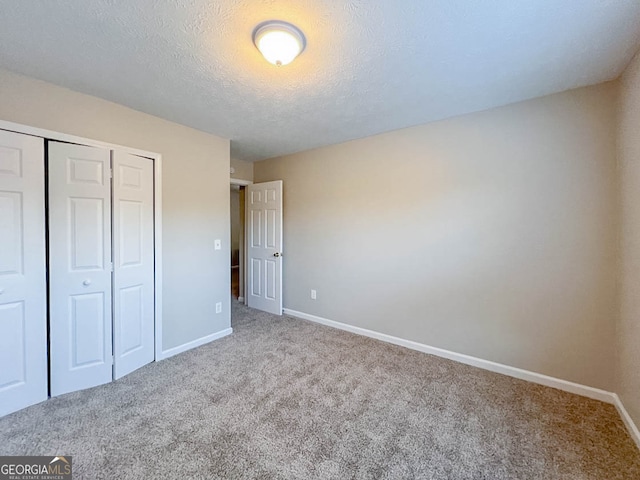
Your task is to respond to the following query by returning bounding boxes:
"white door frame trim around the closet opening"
[0,120,164,362]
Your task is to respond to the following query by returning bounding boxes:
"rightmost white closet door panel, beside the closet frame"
[113,151,155,378]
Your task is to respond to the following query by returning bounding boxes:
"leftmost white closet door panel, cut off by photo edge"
[0,130,48,416]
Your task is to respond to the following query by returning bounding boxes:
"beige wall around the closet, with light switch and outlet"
[0,70,230,350]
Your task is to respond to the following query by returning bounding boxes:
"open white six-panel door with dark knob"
[245,180,282,315]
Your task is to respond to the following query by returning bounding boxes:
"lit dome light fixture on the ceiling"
[253,20,307,67]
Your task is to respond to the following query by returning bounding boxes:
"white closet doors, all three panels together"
[0,130,155,415]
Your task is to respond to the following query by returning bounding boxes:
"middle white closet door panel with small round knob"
[48,142,113,396]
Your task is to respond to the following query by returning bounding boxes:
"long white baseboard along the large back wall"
[284,308,615,404]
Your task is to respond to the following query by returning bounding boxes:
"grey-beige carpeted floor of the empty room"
[0,303,640,480]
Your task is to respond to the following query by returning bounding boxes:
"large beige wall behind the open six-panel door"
[254,83,620,390]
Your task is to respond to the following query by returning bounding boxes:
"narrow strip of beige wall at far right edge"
[616,54,640,426]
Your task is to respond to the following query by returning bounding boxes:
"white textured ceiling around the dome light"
[0,0,640,160]
